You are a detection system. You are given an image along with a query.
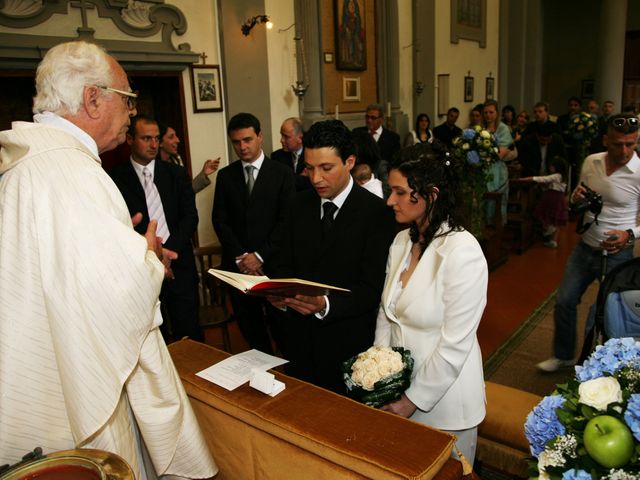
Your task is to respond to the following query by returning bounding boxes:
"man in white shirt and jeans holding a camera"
[537,114,640,372]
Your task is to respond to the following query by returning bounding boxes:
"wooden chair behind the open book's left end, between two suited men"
[193,246,233,352]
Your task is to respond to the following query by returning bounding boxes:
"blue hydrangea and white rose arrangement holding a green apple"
[525,338,640,480]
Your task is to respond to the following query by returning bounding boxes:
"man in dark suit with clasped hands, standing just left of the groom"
[211,113,295,353]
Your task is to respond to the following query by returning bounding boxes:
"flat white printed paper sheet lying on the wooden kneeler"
[196,349,289,390]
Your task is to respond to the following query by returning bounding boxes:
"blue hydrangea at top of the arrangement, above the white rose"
[576,338,640,382]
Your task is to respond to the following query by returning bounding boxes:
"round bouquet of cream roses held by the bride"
[342,345,413,408]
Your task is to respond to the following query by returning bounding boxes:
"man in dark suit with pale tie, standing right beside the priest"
[110,115,203,341]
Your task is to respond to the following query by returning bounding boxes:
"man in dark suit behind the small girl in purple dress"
[518,122,567,177]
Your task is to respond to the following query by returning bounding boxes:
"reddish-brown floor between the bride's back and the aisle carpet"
[205,224,577,359]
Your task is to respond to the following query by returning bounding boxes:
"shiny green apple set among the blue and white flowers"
[583,415,634,468]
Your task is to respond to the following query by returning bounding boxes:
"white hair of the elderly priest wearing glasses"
[33,41,112,116]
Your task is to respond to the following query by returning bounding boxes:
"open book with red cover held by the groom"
[209,268,350,297]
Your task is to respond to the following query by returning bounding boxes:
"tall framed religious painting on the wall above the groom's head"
[334,0,367,70]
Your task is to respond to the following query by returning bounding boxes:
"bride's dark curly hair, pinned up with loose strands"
[389,140,464,254]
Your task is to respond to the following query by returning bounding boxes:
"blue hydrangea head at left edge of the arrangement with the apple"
[524,395,566,458]
